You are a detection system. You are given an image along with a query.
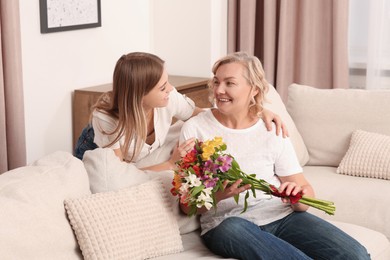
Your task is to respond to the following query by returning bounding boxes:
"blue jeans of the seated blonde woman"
[202,212,370,260]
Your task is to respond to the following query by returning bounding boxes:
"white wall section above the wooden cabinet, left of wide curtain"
[153,0,227,77]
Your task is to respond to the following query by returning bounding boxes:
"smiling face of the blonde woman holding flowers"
[212,62,258,115]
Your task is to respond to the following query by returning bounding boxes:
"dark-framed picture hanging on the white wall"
[39,0,102,33]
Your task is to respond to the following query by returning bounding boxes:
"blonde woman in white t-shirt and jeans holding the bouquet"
[180,53,370,260]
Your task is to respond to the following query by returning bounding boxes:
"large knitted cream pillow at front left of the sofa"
[64,178,183,259]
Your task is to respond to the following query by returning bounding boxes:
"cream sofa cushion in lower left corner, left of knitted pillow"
[0,152,91,259]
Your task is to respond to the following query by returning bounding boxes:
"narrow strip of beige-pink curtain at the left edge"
[0,0,26,174]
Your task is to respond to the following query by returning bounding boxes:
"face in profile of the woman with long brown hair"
[142,70,173,110]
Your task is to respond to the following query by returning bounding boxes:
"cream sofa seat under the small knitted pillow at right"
[303,166,390,238]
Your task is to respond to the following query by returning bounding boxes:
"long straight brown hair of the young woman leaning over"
[93,52,164,161]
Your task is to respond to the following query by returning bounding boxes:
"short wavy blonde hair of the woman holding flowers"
[209,52,269,116]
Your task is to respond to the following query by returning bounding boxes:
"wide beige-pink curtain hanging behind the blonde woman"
[228,0,349,101]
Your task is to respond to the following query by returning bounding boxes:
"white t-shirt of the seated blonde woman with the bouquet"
[180,110,302,234]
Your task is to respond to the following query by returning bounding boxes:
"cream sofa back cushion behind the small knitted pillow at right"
[287,84,390,167]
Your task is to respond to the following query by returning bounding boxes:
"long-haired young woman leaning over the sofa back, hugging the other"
[75,52,287,171]
